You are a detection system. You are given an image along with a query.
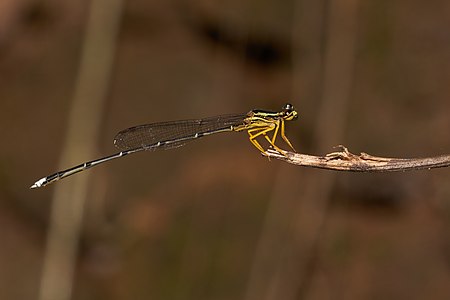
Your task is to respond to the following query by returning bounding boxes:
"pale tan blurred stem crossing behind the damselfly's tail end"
[39,0,122,300]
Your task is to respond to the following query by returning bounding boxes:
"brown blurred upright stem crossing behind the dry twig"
[293,0,359,299]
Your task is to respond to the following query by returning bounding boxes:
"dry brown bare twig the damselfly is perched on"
[264,145,450,172]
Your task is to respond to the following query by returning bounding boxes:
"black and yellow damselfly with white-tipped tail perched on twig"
[31,103,298,188]
